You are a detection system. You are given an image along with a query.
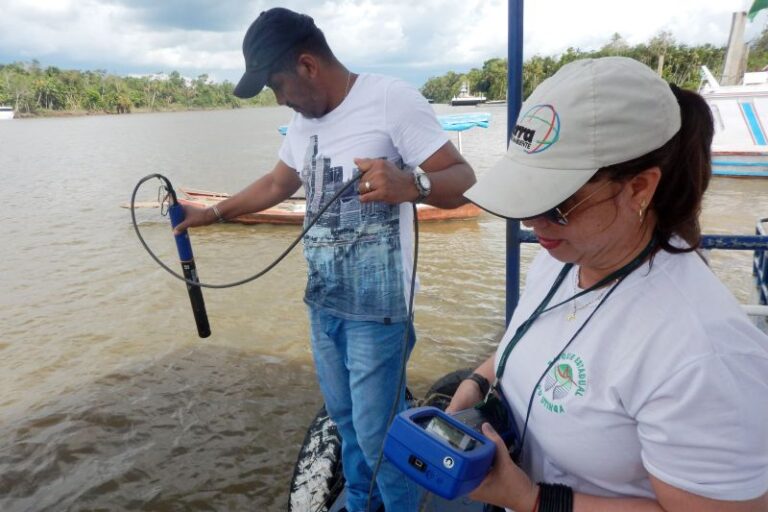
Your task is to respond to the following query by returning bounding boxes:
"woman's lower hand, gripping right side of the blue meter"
[464,424,539,512]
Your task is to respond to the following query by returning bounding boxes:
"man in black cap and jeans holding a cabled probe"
[177,8,475,512]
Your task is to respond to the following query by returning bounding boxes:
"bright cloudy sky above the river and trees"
[0,0,768,86]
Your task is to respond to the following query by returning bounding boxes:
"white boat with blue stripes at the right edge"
[699,66,768,177]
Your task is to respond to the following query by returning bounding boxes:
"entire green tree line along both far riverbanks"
[0,28,768,115]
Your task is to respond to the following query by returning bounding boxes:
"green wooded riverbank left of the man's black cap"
[0,61,277,116]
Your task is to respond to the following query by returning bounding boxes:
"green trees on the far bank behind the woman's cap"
[421,29,768,103]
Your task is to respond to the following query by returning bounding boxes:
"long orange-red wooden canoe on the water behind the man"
[178,187,482,224]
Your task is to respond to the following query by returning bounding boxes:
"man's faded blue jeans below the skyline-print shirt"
[309,307,421,512]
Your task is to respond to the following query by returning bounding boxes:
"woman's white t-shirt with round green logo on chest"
[496,246,768,500]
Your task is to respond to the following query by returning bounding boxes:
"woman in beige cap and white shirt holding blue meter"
[449,57,768,512]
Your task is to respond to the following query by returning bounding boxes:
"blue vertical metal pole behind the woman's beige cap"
[506,0,523,324]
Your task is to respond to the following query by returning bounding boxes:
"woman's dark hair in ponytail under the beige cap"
[593,84,714,253]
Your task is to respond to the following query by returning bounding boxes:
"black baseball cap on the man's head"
[235,7,318,98]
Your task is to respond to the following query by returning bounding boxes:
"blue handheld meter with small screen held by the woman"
[384,407,496,500]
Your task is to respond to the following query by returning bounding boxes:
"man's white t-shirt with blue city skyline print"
[279,74,448,322]
